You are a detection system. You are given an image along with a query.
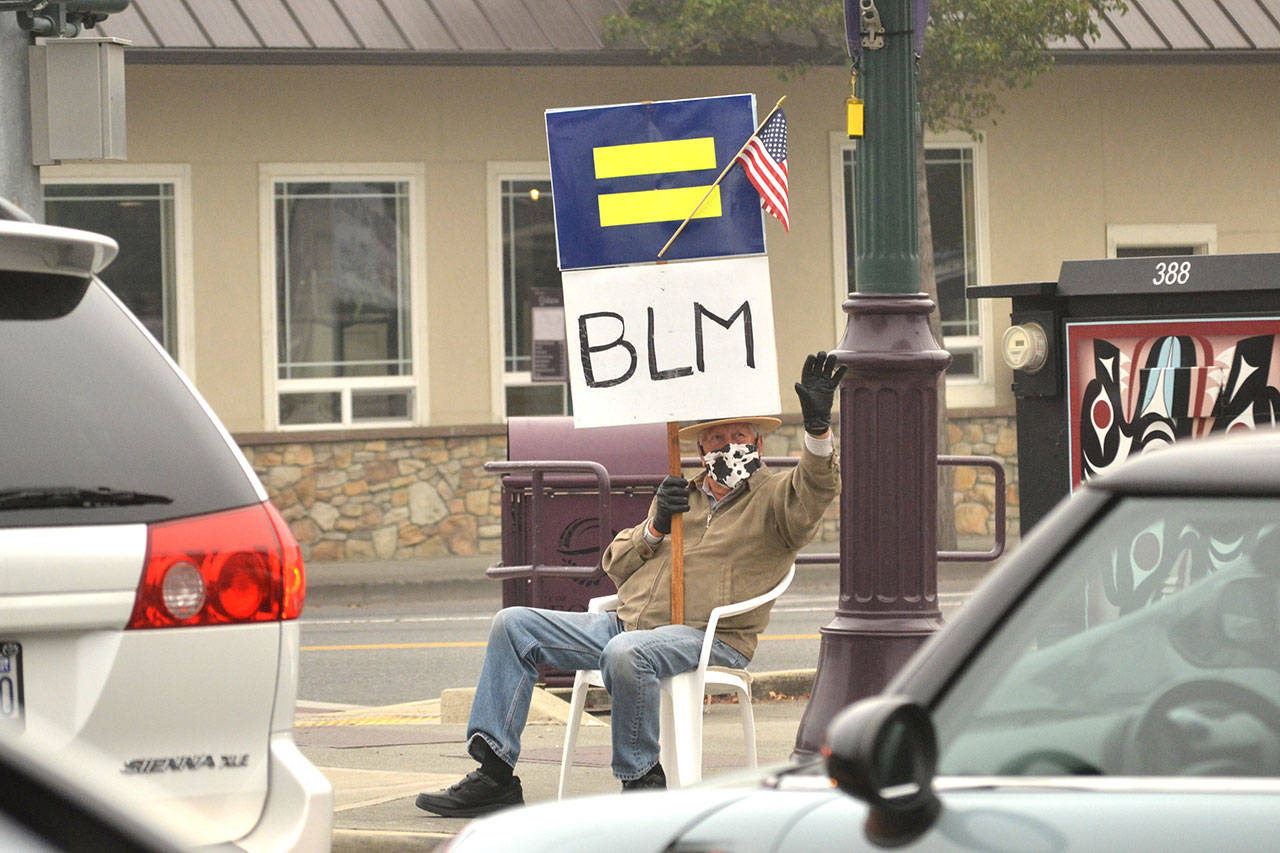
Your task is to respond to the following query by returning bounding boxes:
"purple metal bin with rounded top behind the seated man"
[485,418,667,686]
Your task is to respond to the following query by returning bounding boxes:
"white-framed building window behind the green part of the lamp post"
[842,145,983,380]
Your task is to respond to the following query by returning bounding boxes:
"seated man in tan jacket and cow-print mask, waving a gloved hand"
[417,352,845,817]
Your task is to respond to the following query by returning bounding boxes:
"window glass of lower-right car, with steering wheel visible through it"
[934,497,1280,776]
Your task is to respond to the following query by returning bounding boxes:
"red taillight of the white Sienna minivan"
[127,503,306,628]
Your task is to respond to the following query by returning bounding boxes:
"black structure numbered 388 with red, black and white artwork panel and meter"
[966,254,1280,535]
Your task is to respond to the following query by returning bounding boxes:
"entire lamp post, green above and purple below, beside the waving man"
[796,0,951,756]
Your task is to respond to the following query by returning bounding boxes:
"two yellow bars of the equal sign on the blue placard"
[591,136,721,228]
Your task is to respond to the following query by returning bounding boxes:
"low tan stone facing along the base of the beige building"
[237,418,1018,561]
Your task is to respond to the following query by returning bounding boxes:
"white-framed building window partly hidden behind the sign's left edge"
[498,177,572,418]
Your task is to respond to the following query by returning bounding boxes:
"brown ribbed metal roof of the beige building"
[99,0,1280,64]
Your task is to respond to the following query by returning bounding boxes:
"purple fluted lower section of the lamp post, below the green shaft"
[796,293,951,754]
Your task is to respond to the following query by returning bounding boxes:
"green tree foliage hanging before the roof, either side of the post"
[605,0,1124,132]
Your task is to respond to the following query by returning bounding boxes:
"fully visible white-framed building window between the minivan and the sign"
[273,179,415,428]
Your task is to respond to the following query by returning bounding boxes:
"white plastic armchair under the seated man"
[556,564,796,799]
